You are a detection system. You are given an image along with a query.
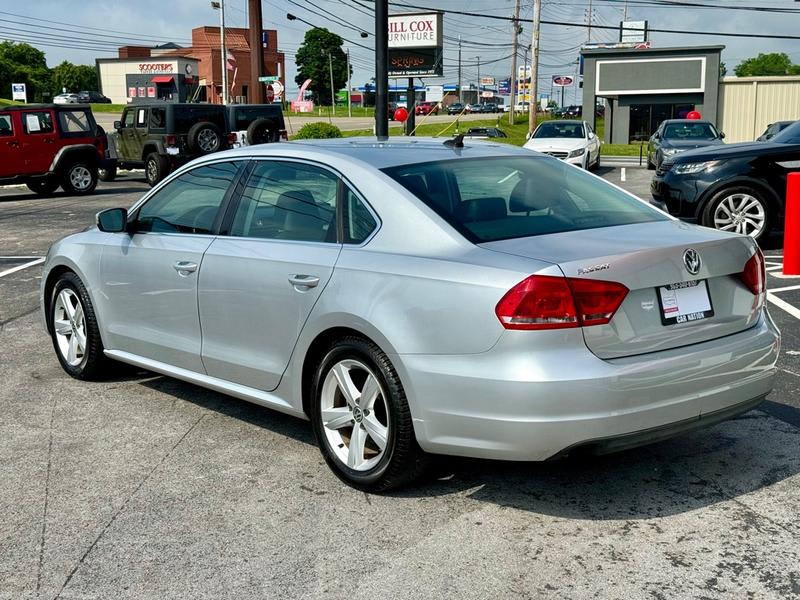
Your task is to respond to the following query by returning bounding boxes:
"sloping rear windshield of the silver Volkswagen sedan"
[383,156,669,243]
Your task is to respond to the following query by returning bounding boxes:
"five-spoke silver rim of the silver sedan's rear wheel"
[320,359,389,471]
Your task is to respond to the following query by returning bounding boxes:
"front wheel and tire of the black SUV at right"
[701,185,772,242]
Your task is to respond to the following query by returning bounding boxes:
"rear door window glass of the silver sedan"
[230,161,339,243]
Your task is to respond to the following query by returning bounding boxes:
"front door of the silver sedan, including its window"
[97,161,245,373]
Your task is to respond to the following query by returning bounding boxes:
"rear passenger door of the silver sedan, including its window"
[199,160,376,391]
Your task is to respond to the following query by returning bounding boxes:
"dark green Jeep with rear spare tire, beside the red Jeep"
[102,102,228,186]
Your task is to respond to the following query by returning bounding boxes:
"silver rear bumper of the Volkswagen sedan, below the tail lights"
[398,312,780,460]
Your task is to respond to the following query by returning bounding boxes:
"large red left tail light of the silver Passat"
[495,275,628,330]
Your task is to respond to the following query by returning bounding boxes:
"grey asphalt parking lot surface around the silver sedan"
[0,167,800,600]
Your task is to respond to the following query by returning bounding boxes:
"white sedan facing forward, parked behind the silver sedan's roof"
[523,120,600,169]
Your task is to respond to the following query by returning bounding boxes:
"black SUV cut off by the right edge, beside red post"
[650,122,800,240]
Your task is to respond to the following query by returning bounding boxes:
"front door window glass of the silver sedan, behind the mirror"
[136,162,239,234]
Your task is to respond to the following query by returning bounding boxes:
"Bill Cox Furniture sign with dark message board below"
[388,12,444,77]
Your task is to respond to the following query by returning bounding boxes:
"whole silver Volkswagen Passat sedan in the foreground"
[42,139,779,490]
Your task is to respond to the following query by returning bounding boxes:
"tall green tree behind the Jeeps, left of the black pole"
[294,27,347,105]
